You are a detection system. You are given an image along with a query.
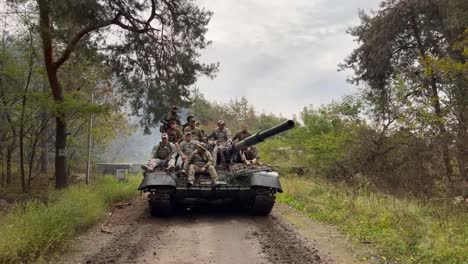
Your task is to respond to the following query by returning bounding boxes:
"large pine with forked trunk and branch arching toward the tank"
[11,0,217,188]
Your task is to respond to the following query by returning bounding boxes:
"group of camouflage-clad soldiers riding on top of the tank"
[142,106,261,186]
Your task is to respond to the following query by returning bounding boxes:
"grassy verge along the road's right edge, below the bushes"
[278,177,468,264]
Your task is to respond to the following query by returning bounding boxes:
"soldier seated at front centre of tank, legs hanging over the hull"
[181,144,221,186]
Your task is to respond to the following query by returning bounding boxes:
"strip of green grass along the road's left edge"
[0,176,141,263]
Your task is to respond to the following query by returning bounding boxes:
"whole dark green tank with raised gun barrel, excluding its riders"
[138,120,295,216]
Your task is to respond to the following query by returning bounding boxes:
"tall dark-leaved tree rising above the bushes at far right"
[340,0,468,183]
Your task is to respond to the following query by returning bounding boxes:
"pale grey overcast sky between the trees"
[197,0,380,117]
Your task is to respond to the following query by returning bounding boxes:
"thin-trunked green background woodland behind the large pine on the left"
[0,16,130,192]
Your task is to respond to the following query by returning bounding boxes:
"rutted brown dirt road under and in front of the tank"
[53,199,364,263]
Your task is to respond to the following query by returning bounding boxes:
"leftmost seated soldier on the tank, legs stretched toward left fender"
[141,133,176,172]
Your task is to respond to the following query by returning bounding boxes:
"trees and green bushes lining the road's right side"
[263,0,468,196]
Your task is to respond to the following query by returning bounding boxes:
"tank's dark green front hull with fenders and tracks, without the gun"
[138,170,282,216]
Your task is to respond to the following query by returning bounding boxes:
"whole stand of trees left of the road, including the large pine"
[0,0,217,191]
